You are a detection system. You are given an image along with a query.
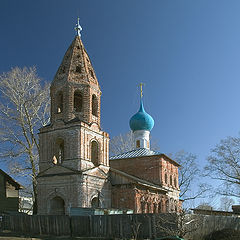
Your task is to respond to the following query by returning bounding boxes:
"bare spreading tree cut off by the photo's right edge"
[205,136,240,198]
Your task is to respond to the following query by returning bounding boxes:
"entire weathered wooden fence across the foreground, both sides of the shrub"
[0,213,240,239]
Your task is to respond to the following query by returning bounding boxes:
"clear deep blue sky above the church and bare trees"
[0,0,240,197]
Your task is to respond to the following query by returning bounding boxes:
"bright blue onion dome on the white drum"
[129,99,154,131]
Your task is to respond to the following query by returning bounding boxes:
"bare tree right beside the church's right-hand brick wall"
[170,150,210,201]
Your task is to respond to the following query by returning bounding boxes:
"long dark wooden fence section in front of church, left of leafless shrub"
[1,214,172,239]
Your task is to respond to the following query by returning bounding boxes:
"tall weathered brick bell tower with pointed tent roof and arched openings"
[38,19,111,214]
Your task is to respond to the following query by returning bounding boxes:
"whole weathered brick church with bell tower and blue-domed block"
[37,21,180,215]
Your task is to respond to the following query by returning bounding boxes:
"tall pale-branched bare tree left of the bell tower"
[0,67,50,213]
